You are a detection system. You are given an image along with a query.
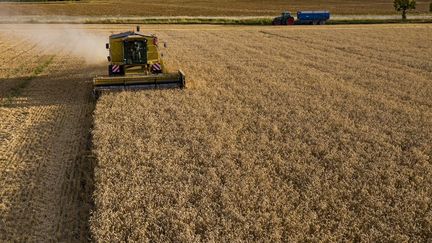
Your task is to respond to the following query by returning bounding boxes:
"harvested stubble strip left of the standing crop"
[0,32,101,242]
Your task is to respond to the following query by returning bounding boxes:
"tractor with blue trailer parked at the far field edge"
[272,11,330,25]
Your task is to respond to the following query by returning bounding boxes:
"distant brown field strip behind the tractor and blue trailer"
[0,0,429,16]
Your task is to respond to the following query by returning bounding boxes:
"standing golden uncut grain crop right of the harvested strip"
[91,25,432,242]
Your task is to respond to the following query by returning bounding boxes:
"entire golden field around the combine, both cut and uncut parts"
[0,24,432,242]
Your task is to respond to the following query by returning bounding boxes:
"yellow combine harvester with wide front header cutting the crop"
[93,27,186,98]
